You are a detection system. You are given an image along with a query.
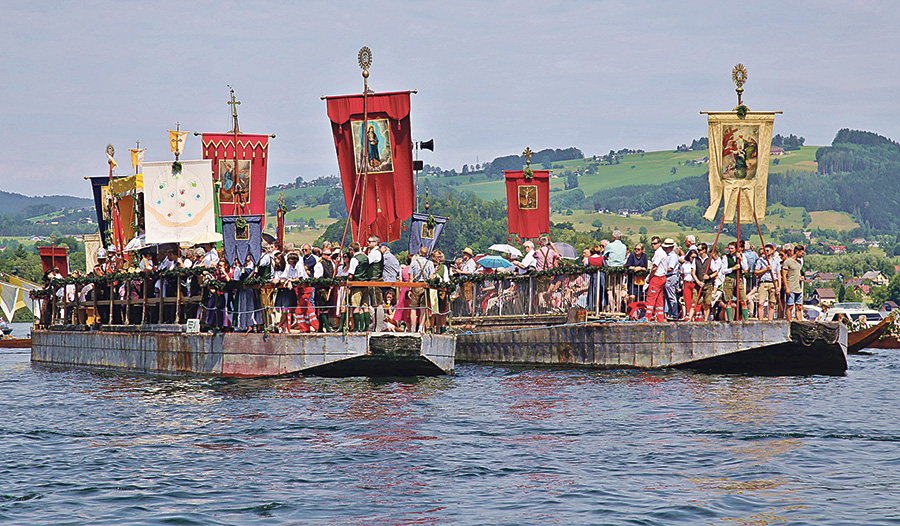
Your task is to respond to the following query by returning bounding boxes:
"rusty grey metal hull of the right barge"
[456,317,847,375]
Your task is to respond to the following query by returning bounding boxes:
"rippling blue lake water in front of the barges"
[0,324,900,525]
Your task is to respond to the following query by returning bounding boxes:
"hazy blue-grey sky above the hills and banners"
[0,0,900,197]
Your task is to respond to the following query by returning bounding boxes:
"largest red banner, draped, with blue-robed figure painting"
[327,91,415,245]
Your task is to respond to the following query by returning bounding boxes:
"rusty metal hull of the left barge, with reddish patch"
[31,326,456,377]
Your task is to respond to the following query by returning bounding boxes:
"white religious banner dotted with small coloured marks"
[143,160,216,244]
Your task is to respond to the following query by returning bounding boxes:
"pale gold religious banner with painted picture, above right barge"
[703,111,775,223]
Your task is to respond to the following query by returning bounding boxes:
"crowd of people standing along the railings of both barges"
[45,230,804,333]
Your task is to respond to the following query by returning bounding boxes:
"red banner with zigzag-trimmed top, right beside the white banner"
[202,132,269,223]
